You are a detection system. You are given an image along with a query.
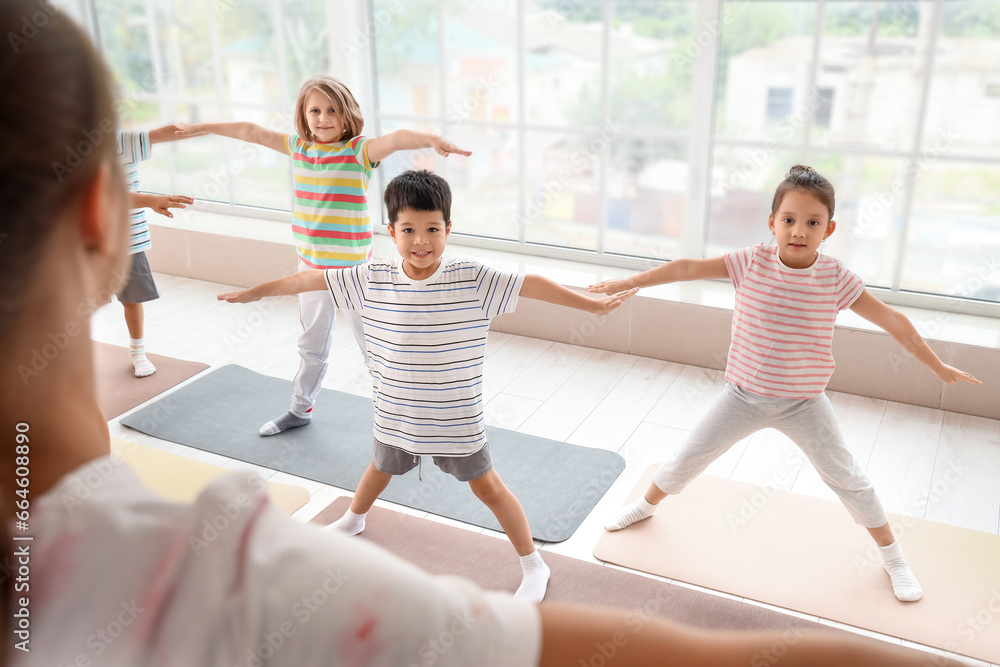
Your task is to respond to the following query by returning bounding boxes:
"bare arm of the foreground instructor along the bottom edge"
[538,603,961,667]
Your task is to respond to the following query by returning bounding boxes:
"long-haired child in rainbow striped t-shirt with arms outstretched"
[177,75,471,435]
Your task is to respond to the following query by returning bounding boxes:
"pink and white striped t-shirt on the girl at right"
[725,243,865,398]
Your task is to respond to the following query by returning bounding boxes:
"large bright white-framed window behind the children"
[93,0,1000,312]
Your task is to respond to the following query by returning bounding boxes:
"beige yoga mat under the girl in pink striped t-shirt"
[594,464,1000,663]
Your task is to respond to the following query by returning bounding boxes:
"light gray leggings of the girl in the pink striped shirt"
[653,382,888,528]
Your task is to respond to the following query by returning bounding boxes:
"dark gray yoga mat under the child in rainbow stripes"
[121,365,625,542]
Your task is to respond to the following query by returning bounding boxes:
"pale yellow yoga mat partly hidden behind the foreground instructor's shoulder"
[111,438,309,514]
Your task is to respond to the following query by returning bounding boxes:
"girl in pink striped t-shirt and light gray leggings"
[590,166,982,601]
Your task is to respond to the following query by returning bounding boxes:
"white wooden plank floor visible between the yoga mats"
[93,274,1000,667]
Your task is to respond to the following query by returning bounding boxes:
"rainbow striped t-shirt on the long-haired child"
[285,134,379,269]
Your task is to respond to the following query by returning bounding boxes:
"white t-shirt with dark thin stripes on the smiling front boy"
[326,259,524,456]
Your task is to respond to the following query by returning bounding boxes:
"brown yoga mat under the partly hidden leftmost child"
[92,340,208,419]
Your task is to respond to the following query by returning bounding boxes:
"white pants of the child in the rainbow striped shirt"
[290,262,368,417]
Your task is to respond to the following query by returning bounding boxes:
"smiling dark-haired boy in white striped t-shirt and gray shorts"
[219,171,635,601]
